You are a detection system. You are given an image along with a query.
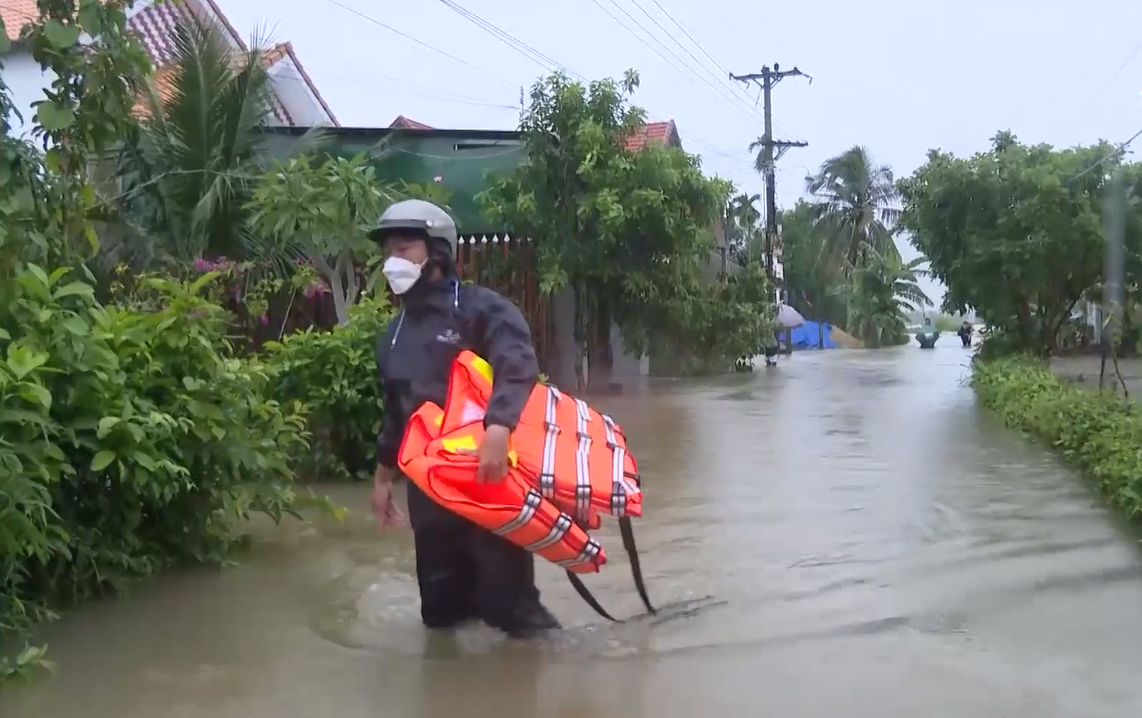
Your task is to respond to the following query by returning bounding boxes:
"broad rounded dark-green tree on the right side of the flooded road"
[900,132,1118,354]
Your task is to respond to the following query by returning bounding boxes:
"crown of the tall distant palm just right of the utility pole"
[806,145,900,275]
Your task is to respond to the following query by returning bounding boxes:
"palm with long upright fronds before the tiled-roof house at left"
[107,22,317,269]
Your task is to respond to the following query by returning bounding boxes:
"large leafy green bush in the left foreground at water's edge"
[0,265,307,677]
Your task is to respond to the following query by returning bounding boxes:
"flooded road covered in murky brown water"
[0,342,1142,718]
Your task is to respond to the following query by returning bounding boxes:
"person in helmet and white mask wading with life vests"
[369,200,560,638]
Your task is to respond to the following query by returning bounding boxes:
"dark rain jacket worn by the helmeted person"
[377,271,539,526]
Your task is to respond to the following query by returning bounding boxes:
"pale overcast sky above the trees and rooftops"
[218,0,1142,305]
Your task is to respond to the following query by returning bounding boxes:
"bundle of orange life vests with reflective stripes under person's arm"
[397,350,654,619]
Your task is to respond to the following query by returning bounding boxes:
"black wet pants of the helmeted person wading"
[409,485,560,638]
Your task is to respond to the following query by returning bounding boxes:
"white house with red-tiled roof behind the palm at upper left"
[0,0,338,135]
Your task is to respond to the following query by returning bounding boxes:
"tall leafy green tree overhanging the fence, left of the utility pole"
[481,71,761,374]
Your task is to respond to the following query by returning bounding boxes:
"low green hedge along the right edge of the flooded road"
[972,357,1142,518]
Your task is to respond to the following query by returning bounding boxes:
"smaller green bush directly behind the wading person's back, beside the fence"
[265,298,394,479]
